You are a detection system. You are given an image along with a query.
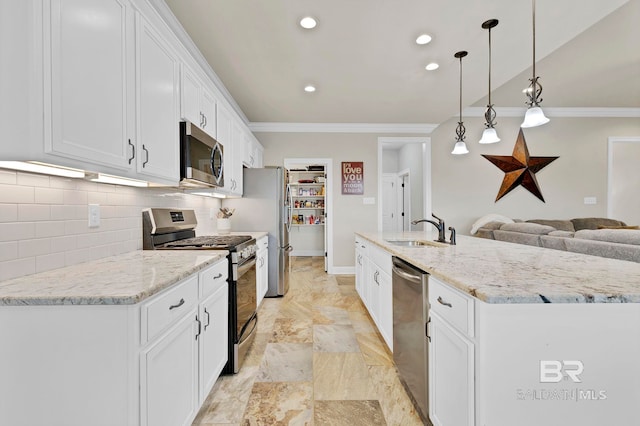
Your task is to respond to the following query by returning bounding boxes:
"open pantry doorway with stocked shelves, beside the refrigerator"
[284,158,333,272]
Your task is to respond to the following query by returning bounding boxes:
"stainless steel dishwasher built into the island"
[392,256,431,425]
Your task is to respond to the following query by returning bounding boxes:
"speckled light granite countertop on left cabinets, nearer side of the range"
[0,250,228,306]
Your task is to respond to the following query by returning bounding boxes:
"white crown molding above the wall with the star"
[463,107,640,118]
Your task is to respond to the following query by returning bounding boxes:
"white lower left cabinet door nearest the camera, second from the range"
[140,309,199,426]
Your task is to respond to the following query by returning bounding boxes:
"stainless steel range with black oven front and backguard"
[142,208,258,373]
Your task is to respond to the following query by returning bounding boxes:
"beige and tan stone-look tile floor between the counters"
[193,257,422,426]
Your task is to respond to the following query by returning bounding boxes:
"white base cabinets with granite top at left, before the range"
[0,250,229,426]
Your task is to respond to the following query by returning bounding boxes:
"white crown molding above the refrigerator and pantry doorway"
[249,122,438,134]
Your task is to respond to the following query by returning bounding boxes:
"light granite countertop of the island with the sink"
[356,232,640,303]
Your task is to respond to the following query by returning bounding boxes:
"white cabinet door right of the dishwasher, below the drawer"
[429,312,474,426]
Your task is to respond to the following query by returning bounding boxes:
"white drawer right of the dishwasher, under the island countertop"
[429,276,473,337]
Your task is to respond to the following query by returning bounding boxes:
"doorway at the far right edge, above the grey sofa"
[607,137,640,225]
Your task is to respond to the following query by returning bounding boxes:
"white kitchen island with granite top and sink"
[356,232,640,426]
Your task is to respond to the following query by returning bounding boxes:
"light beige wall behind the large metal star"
[431,117,640,234]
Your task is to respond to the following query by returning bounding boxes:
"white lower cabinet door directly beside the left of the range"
[199,282,229,404]
